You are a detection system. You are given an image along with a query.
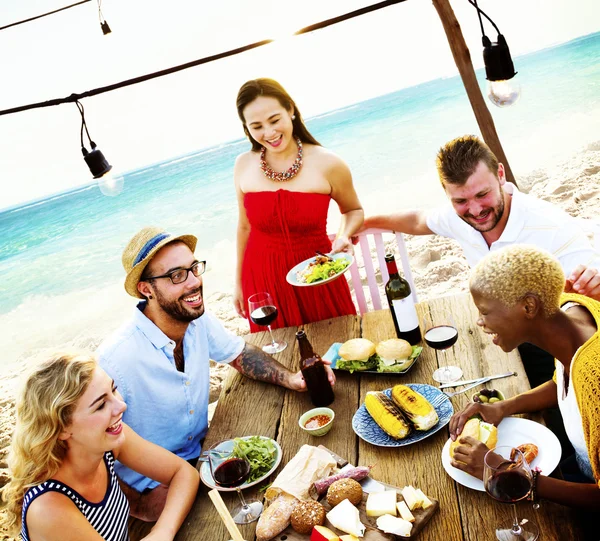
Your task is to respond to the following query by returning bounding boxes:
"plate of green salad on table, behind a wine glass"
[200,436,281,492]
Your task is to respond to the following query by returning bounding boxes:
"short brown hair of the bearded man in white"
[435,135,498,186]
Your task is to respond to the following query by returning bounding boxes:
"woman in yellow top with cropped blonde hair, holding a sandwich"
[450,245,600,509]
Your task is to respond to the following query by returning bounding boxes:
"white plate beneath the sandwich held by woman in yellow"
[442,417,562,492]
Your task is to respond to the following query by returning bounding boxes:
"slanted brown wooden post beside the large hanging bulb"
[432,0,517,186]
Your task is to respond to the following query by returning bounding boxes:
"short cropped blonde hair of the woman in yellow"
[469,244,565,316]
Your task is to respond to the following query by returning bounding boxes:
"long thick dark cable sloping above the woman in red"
[0,0,408,116]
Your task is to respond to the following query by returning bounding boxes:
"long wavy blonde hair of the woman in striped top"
[2,353,97,535]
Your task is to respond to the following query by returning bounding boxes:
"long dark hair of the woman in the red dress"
[236,78,321,152]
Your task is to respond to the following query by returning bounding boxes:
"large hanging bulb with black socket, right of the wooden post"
[482,34,521,107]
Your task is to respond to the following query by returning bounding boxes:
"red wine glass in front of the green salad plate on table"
[208,441,263,524]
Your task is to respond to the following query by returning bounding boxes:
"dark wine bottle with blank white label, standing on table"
[385,254,421,346]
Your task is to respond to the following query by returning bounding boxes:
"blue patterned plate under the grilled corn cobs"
[352,383,454,447]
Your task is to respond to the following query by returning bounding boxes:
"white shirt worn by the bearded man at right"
[427,183,600,276]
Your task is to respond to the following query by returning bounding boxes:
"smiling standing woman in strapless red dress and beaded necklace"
[234,79,364,332]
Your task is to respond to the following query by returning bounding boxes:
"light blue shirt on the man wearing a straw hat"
[98,301,245,492]
